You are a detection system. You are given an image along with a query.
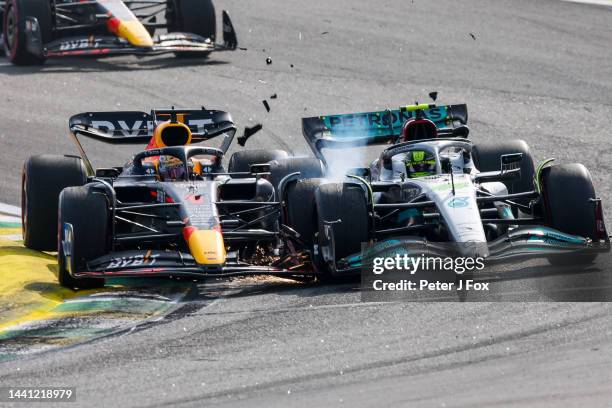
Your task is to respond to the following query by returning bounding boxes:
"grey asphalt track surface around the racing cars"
[0,0,612,407]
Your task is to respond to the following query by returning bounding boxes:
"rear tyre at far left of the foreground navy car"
[21,154,87,251]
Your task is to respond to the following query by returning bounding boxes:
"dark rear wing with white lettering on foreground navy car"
[68,108,236,172]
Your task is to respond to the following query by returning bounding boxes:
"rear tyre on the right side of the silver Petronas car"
[472,140,535,204]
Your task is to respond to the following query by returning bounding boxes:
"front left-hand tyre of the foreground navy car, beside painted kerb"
[57,186,110,289]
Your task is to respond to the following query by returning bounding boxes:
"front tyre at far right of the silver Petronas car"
[541,163,597,265]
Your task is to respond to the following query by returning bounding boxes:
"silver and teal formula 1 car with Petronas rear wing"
[298,104,610,276]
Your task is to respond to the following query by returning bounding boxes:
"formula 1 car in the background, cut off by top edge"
[0,0,238,65]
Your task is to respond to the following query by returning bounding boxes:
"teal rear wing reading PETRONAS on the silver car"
[302,104,468,162]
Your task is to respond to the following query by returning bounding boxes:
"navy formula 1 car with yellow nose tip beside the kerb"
[22,108,323,288]
